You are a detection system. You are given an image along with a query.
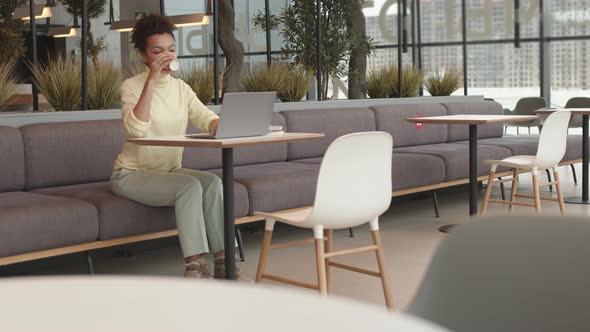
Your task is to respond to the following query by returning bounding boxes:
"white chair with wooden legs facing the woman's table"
[255,132,393,308]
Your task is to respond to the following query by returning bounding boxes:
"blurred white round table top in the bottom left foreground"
[0,277,446,332]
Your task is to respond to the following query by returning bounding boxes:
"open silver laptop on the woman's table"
[186,91,277,139]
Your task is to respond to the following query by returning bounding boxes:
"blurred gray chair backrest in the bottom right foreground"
[407,216,590,332]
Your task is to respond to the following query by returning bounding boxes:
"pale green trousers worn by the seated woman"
[111,168,224,257]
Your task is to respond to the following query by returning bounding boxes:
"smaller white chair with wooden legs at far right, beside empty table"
[481,111,571,214]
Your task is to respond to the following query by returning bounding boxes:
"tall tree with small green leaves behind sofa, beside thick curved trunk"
[254,0,374,99]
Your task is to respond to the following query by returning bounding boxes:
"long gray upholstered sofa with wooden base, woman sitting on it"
[0,101,581,265]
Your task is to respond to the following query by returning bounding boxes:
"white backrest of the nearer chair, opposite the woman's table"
[308,131,393,228]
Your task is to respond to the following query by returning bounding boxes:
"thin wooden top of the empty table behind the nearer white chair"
[406,114,538,125]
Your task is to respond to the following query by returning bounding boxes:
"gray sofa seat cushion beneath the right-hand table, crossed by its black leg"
[394,143,511,181]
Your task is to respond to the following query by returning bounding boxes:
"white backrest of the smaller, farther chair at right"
[535,111,571,168]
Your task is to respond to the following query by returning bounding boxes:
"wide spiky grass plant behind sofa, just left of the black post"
[31,56,82,111]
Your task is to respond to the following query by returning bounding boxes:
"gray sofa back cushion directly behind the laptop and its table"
[182,113,287,170]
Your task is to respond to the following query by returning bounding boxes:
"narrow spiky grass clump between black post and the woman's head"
[88,62,122,110]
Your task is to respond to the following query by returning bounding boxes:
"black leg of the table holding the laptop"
[221,148,236,280]
